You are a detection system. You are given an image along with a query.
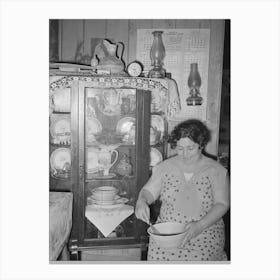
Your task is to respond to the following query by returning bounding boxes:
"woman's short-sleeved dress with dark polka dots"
[144,156,227,261]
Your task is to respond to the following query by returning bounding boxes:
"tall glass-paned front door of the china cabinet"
[74,82,150,243]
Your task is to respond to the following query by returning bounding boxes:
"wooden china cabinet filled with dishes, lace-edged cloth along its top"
[50,71,177,260]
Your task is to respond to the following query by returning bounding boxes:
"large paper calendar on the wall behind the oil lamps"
[136,29,210,121]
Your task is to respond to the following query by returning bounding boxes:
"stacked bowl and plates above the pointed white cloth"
[88,186,128,208]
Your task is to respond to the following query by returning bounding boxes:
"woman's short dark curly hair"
[168,119,210,150]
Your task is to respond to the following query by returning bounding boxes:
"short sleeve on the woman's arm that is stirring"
[143,164,163,201]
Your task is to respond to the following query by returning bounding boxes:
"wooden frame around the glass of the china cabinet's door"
[70,81,151,258]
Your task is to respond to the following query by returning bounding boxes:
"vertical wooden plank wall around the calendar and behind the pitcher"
[59,19,224,155]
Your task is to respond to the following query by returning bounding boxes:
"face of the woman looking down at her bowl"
[176,137,201,162]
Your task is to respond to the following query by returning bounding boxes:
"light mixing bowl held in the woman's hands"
[147,222,186,248]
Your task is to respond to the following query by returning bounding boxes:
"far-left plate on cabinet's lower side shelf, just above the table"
[50,148,71,175]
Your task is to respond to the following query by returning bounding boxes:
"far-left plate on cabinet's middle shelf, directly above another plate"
[50,114,71,144]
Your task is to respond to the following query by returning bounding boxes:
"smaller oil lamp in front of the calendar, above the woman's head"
[186,63,203,106]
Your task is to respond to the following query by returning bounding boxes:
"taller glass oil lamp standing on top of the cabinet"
[148,31,166,78]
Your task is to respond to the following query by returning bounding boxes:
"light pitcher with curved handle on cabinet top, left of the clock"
[91,39,125,74]
